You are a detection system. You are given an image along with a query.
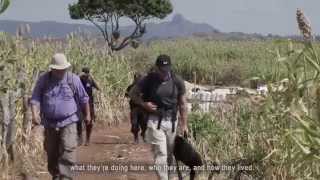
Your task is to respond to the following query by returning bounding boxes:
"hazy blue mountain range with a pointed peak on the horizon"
[0,14,218,40]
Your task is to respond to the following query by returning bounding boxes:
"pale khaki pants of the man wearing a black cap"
[146,115,177,180]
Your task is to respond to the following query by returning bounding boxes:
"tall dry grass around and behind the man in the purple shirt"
[0,35,132,179]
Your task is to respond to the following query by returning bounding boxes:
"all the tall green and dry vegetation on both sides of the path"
[0,27,320,179]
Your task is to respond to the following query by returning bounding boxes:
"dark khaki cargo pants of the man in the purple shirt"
[44,123,78,180]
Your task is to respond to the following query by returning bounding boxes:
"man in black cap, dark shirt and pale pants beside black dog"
[130,54,188,180]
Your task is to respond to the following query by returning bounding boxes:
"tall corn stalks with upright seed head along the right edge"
[258,10,320,179]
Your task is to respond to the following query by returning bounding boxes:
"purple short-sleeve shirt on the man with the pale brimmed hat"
[31,72,89,128]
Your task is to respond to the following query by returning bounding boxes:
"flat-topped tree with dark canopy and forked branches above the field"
[69,0,172,51]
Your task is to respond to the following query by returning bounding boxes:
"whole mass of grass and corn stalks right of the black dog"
[186,10,320,179]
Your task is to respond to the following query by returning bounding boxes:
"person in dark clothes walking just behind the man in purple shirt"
[77,67,100,146]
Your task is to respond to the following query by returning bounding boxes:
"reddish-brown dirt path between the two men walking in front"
[40,122,157,180]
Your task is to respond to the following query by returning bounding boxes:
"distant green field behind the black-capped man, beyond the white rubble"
[127,38,318,86]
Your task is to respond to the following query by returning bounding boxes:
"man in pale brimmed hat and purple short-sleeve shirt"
[31,53,91,180]
